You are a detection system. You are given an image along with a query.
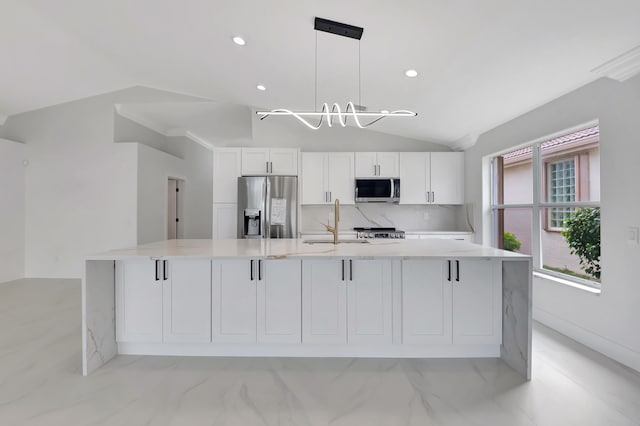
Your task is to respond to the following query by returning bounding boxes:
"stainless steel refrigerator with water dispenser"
[238,176,298,238]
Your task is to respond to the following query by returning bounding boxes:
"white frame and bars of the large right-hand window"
[486,120,602,291]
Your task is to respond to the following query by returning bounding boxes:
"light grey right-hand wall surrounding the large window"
[465,77,640,370]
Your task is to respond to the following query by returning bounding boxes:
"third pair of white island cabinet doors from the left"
[302,259,392,344]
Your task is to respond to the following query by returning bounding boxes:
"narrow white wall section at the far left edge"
[0,139,26,283]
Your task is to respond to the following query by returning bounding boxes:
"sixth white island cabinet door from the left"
[345,259,393,344]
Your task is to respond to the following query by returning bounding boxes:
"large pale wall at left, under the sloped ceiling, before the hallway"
[0,87,202,278]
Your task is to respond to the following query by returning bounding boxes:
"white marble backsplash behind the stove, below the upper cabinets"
[300,203,469,232]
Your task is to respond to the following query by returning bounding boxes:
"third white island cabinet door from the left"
[211,259,257,343]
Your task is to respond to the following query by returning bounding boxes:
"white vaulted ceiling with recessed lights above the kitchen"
[0,0,640,146]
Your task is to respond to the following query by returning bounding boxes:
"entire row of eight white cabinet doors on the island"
[116,258,502,350]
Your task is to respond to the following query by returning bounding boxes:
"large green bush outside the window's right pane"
[562,208,600,279]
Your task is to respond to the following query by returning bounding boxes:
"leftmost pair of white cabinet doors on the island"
[116,259,211,342]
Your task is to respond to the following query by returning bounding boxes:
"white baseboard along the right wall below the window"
[533,307,640,372]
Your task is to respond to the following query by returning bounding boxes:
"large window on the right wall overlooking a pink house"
[491,123,600,287]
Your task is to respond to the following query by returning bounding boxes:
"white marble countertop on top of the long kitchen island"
[86,239,530,260]
